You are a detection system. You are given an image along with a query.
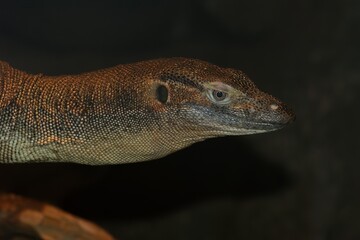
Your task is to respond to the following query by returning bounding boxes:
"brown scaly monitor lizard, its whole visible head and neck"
[0,58,294,165]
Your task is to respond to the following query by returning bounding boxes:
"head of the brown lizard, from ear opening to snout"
[147,58,295,138]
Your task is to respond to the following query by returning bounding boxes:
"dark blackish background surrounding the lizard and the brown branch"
[0,0,360,240]
